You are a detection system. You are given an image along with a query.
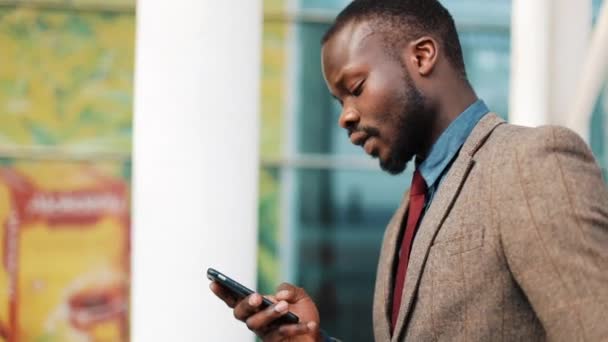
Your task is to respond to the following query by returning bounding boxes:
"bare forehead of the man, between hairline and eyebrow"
[321,22,382,80]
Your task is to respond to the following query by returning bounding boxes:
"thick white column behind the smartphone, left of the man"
[132,0,262,342]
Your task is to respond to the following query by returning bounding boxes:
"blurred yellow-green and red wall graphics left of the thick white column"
[0,0,135,341]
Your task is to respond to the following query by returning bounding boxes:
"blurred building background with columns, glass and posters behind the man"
[0,0,608,341]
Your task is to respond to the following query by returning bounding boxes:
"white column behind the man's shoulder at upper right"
[509,0,592,126]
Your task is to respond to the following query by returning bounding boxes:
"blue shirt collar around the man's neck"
[418,100,489,188]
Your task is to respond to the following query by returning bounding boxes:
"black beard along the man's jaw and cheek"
[380,70,436,175]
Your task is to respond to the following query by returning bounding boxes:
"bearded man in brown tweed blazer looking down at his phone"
[211,0,608,341]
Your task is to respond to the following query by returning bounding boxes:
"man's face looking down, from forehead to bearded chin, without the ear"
[322,22,435,174]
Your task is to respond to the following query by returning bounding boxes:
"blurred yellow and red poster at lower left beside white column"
[0,160,130,342]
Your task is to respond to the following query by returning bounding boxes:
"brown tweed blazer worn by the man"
[373,113,608,341]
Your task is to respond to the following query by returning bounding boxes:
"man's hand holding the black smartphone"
[210,282,321,342]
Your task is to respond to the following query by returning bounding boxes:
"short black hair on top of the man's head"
[321,0,466,79]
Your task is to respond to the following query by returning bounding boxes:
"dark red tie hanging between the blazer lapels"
[391,170,426,334]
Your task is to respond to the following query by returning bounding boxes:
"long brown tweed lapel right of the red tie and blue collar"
[389,114,504,341]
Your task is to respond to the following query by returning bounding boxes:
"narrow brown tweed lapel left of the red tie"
[374,190,410,341]
